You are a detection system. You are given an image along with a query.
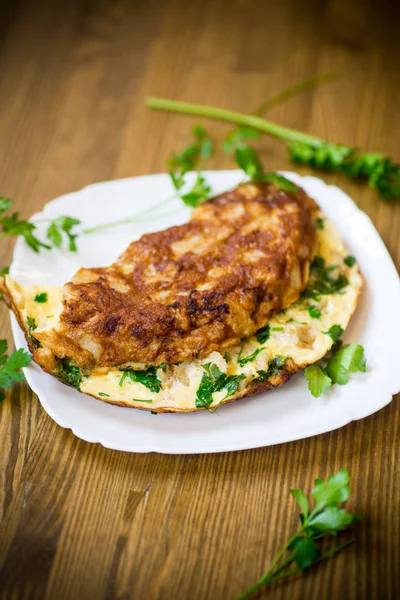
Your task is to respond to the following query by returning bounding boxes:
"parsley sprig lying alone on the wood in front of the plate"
[237,469,362,600]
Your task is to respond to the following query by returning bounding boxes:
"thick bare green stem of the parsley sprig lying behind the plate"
[146,97,324,148]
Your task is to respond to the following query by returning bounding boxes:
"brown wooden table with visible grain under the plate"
[0,0,400,600]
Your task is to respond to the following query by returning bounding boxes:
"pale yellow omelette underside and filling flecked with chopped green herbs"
[0,213,362,412]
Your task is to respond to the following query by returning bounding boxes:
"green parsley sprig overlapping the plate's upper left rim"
[0,198,80,252]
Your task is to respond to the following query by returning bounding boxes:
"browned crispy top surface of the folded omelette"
[37,183,316,367]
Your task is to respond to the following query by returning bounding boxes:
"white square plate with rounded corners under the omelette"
[11,171,400,454]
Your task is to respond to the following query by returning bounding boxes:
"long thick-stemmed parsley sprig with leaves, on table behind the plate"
[146,97,400,200]
